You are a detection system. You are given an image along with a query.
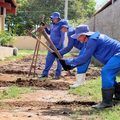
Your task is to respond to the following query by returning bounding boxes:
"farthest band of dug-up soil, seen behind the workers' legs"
[0,56,100,80]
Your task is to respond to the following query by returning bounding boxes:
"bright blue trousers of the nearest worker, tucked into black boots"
[101,55,120,89]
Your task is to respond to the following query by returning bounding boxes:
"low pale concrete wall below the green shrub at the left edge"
[0,47,13,59]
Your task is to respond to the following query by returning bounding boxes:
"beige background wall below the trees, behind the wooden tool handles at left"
[13,36,46,50]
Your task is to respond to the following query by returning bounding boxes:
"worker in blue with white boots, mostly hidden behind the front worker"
[59,24,90,88]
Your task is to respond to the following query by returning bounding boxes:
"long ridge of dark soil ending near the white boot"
[0,78,69,90]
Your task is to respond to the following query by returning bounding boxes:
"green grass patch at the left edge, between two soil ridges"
[0,86,32,100]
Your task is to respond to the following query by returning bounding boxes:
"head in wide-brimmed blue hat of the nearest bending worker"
[71,25,94,42]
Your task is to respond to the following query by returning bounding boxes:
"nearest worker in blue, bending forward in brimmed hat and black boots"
[60,25,120,109]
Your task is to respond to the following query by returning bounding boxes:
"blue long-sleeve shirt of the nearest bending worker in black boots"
[66,33,120,66]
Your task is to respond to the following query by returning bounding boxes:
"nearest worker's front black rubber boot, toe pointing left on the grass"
[92,88,114,109]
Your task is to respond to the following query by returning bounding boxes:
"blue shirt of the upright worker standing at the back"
[45,20,65,49]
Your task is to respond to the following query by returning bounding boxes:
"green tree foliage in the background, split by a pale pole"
[6,0,95,35]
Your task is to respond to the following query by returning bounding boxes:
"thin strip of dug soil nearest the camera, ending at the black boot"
[0,101,96,109]
